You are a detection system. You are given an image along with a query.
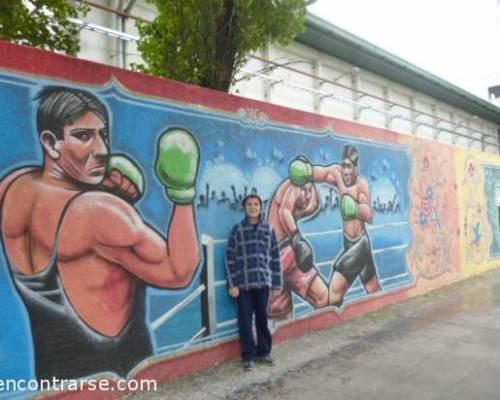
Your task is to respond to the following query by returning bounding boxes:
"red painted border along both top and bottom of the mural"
[0,40,411,399]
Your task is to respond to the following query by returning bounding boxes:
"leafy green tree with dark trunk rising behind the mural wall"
[134,0,315,92]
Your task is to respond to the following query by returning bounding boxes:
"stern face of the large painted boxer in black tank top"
[57,111,109,185]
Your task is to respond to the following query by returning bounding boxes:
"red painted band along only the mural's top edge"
[0,40,400,144]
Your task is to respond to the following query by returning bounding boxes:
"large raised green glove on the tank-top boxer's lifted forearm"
[155,128,200,204]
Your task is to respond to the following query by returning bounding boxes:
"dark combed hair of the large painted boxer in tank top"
[36,86,109,139]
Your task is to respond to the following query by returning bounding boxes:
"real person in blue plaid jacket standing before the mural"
[226,194,282,370]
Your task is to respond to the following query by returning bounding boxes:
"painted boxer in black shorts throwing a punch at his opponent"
[312,145,381,306]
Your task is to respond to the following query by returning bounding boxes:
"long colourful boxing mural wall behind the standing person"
[0,43,500,398]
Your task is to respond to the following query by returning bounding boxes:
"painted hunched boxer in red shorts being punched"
[268,157,329,319]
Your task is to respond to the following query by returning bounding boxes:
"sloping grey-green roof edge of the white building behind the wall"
[295,14,500,124]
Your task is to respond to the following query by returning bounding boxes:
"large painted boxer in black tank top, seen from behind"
[0,87,200,379]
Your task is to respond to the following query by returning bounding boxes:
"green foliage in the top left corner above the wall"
[0,0,88,55]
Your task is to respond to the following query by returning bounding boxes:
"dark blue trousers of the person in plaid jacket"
[238,287,272,361]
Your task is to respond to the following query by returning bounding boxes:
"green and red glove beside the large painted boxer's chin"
[102,154,144,204]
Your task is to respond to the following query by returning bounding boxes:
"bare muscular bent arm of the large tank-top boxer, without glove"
[66,192,200,288]
